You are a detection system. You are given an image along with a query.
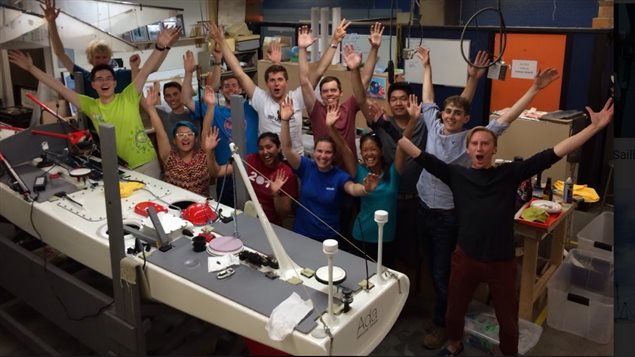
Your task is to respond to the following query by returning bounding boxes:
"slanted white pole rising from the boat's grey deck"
[229,143,300,280]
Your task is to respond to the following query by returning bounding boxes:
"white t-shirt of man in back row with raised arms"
[251,87,304,155]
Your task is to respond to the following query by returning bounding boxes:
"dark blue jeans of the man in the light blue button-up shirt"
[419,200,459,327]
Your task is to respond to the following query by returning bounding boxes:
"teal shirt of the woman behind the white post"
[353,164,399,243]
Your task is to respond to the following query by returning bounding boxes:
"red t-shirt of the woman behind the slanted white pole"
[246,154,298,226]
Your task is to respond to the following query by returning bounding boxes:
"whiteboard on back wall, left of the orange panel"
[404,38,470,87]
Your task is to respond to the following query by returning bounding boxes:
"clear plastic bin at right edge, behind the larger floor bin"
[577,212,613,259]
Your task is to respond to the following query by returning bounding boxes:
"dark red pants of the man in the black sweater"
[445,245,518,355]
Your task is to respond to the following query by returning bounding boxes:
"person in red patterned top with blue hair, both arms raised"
[142,85,215,197]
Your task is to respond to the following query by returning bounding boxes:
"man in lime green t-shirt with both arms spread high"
[9,27,180,178]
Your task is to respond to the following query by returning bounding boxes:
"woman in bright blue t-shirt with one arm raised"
[280,97,379,243]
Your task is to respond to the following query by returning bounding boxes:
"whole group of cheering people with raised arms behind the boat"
[9,0,613,355]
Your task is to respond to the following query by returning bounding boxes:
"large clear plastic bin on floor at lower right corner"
[547,249,613,343]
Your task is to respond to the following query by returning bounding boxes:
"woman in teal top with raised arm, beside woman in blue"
[325,97,404,266]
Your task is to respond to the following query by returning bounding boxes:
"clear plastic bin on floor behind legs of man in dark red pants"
[463,301,542,355]
